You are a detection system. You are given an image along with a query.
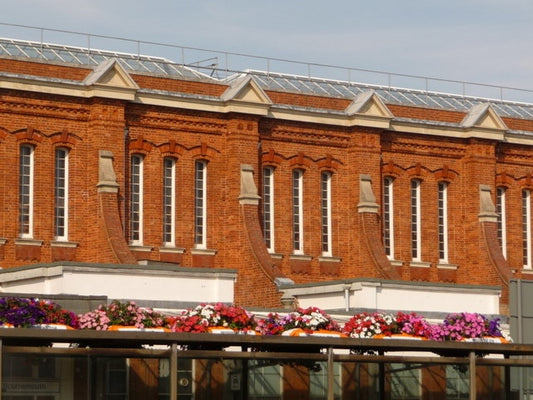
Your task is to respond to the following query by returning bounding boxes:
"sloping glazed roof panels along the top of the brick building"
[0,38,533,119]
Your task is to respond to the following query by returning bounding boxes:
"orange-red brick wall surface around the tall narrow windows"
[0,56,533,306]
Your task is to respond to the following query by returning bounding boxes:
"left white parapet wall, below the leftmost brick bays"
[0,263,237,303]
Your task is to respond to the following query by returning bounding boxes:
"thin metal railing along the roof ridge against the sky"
[0,22,533,103]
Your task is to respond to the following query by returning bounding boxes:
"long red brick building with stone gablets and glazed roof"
[0,37,533,312]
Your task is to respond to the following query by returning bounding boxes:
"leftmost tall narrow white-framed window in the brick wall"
[19,145,34,238]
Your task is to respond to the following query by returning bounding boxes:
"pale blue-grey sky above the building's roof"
[0,0,533,100]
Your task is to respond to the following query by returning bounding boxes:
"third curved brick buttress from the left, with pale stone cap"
[357,174,401,279]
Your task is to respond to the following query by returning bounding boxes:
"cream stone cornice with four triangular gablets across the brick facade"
[0,70,533,145]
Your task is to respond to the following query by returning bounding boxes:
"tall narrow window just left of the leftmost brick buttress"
[54,148,69,240]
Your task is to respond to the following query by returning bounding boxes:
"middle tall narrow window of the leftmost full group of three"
[163,157,176,246]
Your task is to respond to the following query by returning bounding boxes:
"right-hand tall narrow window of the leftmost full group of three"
[194,161,207,249]
